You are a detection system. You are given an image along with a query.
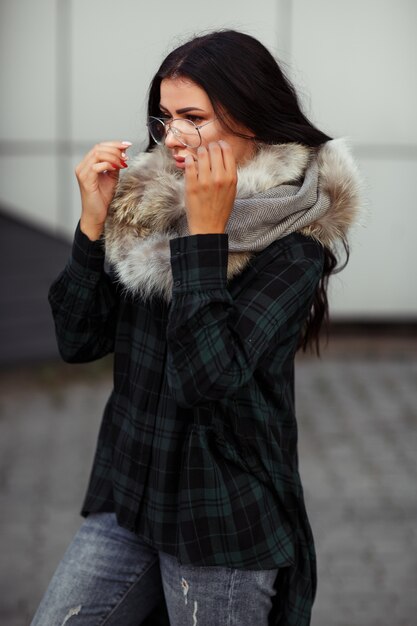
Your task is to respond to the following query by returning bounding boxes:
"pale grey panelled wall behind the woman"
[0,0,417,320]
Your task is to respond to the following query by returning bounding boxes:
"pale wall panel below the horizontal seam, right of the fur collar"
[331,159,417,320]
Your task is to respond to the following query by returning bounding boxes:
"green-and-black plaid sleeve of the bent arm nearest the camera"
[167,234,323,406]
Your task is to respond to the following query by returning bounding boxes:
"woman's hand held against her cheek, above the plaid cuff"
[185,141,237,235]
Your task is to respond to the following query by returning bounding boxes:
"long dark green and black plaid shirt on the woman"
[50,228,323,626]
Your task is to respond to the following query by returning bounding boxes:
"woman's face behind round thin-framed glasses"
[160,78,254,169]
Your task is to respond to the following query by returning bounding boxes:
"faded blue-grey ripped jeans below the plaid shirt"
[31,513,278,626]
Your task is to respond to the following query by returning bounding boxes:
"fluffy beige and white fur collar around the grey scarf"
[105,139,360,299]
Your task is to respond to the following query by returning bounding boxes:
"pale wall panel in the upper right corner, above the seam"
[291,0,417,144]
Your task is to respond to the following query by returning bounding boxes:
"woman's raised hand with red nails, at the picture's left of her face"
[75,141,132,241]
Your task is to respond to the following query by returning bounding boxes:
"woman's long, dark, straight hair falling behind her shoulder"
[148,30,348,352]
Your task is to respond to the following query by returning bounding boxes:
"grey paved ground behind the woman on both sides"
[0,337,417,626]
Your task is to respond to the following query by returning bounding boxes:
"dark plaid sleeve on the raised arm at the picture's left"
[49,225,118,363]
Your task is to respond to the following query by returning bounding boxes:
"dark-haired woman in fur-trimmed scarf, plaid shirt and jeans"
[33,31,358,626]
